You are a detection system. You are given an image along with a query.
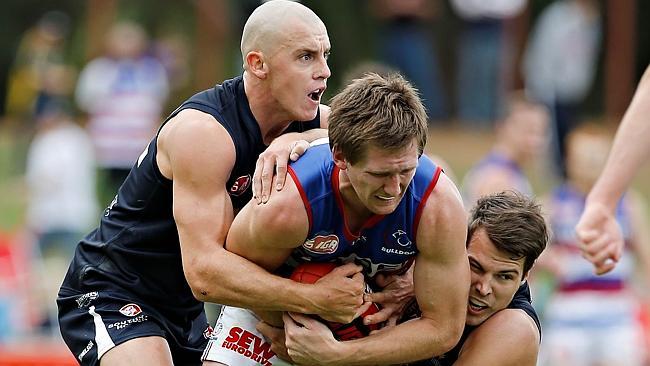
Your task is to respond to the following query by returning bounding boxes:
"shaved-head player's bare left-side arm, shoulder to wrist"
[157,110,362,318]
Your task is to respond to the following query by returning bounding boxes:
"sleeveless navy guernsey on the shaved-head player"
[58,76,320,362]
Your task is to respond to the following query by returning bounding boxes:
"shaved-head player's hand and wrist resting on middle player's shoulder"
[253,104,330,204]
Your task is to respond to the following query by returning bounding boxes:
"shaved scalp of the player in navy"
[241,0,324,65]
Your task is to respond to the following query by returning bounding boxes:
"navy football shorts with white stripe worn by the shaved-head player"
[56,288,211,365]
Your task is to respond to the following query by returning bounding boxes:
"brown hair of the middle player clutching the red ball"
[328,73,427,164]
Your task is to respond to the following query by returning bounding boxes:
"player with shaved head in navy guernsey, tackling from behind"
[57,0,364,365]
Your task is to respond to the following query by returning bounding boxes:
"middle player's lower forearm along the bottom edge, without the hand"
[332,318,462,365]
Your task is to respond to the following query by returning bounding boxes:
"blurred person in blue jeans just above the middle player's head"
[370,0,447,120]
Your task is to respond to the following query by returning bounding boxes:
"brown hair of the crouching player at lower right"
[467,191,549,276]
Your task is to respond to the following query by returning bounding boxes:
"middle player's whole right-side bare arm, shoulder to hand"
[285,176,469,365]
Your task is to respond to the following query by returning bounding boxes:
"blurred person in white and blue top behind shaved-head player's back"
[76,22,168,200]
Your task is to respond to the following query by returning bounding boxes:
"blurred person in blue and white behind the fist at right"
[537,125,650,366]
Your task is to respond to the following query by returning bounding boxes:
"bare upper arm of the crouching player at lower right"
[454,309,540,366]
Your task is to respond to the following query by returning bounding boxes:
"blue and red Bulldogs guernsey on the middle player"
[283,144,441,277]
